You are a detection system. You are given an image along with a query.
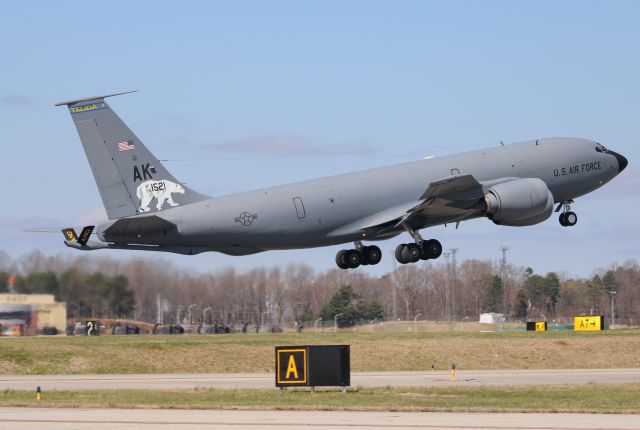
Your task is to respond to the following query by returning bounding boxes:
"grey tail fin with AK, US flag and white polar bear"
[56,91,208,219]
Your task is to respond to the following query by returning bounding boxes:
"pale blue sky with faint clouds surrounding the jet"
[0,1,640,275]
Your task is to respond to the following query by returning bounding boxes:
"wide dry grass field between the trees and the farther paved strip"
[0,330,640,375]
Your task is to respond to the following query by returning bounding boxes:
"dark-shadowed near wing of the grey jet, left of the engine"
[331,175,484,237]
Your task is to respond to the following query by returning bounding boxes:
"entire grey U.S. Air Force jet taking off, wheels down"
[57,93,627,269]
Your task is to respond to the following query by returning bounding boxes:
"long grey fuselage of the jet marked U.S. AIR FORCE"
[98,138,620,255]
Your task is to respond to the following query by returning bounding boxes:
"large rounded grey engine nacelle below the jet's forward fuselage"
[484,178,553,226]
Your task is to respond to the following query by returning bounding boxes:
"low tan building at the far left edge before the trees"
[0,294,67,336]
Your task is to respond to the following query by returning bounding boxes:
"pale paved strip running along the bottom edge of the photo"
[0,408,640,430]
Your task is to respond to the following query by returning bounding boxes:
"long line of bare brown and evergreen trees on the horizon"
[0,251,640,325]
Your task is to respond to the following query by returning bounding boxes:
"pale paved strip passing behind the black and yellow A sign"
[0,369,640,390]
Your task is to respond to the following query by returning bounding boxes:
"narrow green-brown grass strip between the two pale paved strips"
[0,384,640,414]
